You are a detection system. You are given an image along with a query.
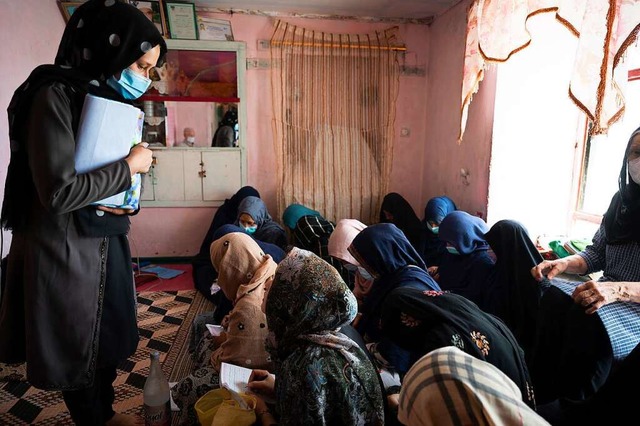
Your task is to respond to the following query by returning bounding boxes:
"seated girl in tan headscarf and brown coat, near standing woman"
[210,232,277,371]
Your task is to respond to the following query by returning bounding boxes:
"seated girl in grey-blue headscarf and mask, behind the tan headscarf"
[235,196,287,250]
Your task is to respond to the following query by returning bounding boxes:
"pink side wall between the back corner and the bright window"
[420,0,496,218]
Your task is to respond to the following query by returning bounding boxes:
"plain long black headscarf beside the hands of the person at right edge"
[484,220,548,358]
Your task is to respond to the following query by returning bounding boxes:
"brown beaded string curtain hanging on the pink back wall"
[271,21,404,223]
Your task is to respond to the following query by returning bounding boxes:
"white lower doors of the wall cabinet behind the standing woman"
[141,148,243,207]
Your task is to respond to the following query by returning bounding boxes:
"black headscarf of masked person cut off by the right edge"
[604,128,640,244]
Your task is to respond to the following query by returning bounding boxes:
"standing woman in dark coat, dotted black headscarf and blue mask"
[0,0,166,425]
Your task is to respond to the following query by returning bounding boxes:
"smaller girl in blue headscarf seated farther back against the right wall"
[422,195,457,267]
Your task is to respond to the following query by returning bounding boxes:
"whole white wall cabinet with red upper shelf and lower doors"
[140,40,246,207]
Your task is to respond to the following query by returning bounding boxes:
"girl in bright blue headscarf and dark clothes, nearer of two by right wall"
[437,210,494,311]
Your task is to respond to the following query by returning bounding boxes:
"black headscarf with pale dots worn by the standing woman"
[1,0,167,229]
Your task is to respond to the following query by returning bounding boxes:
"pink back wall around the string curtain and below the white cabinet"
[131,14,429,257]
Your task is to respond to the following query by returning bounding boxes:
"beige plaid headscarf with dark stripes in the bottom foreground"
[398,346,548,426]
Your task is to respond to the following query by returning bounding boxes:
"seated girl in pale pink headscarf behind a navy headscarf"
[327,219,373,308]
